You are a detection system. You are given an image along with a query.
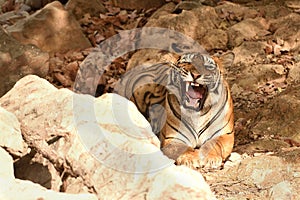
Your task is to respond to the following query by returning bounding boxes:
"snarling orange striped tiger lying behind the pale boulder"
[114,52,234,169]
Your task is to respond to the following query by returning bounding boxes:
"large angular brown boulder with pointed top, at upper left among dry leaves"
[7,1,91,52]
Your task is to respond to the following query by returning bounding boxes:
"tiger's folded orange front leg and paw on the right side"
[176,133,234,169]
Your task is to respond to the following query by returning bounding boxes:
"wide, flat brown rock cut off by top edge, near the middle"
[112,0,165,10]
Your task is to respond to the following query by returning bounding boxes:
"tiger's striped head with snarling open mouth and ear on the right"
[173,53,234,111]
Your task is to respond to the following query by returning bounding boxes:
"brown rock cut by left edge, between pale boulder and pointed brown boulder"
[0,27,49,96]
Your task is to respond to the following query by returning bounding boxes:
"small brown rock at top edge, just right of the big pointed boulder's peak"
[66,0,107,19]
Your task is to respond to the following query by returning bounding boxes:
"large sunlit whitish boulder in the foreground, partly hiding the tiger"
[0,75,214,199]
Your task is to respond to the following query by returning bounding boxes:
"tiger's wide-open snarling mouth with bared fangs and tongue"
[183,81,208,111]
